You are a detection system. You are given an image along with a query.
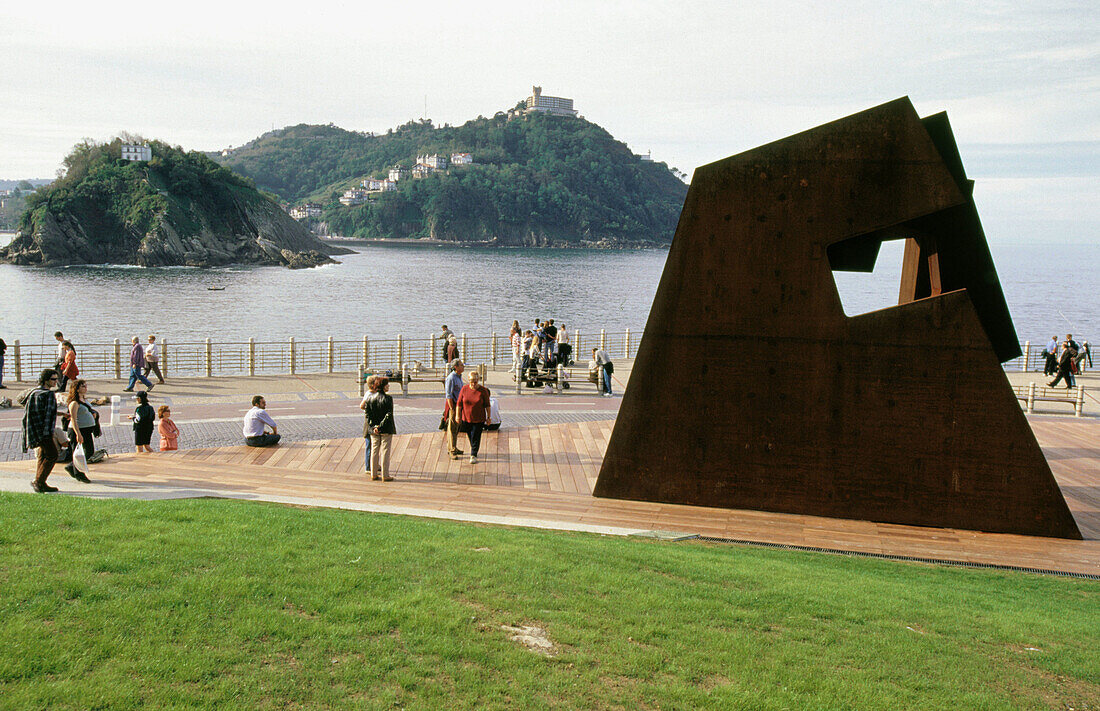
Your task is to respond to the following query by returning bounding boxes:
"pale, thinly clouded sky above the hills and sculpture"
[0,0,1100,244]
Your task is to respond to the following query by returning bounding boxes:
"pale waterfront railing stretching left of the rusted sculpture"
[3,329,641,381]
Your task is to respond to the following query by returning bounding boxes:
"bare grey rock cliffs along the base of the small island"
[0,192,348,269]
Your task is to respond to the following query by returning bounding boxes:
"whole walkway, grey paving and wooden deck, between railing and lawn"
[0,363,1100,575]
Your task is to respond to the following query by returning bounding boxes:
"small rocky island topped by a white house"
[0,136,347,269]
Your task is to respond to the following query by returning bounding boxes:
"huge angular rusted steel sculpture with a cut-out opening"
[594,98,1081,538]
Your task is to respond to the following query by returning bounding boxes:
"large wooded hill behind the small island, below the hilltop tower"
[216,113,688,247]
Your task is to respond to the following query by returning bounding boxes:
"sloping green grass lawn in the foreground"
[0,494,1100,710]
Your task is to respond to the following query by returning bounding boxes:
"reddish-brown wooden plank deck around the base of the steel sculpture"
[0,418,1100,575]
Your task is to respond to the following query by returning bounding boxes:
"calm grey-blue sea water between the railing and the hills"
[0,242,1100,343]
